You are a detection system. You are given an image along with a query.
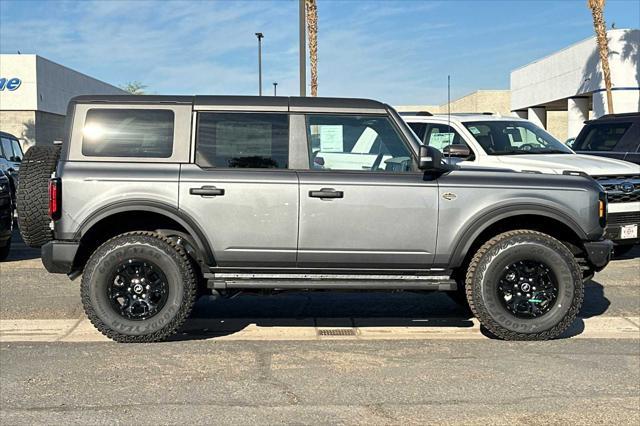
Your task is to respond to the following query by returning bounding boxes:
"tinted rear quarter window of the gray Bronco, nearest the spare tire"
[82,109,174,158]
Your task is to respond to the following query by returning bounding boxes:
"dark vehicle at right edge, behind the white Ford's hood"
[570,112,640,164]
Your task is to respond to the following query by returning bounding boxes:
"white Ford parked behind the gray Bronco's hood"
[403,114,640,254]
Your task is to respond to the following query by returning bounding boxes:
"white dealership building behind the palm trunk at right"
[511,29,640,137]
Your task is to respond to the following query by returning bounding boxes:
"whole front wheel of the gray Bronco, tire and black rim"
[465,230,584,340]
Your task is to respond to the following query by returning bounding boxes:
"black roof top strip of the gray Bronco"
[71,95,387,110]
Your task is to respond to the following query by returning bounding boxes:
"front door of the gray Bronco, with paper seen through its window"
[298,114,438,269]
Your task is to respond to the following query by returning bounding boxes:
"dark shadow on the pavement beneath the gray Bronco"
[170,280,611,341]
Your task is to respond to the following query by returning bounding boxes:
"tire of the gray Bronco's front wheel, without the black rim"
[466,230,584,340]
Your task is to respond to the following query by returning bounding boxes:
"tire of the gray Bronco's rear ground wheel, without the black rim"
[80,231,198,343]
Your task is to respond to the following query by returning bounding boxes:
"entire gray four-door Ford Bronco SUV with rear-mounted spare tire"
[18,96,612,342]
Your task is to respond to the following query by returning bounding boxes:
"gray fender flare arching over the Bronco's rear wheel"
[73,200,215,266]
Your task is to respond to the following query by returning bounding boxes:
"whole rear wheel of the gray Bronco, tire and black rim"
[81,232,198,342]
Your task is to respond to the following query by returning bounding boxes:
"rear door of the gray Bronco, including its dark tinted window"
[180,111,298,267]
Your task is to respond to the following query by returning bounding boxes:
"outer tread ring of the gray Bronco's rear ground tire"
[80,231,198,343]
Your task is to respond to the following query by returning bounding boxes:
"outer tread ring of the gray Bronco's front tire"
[465,229,584,340]
